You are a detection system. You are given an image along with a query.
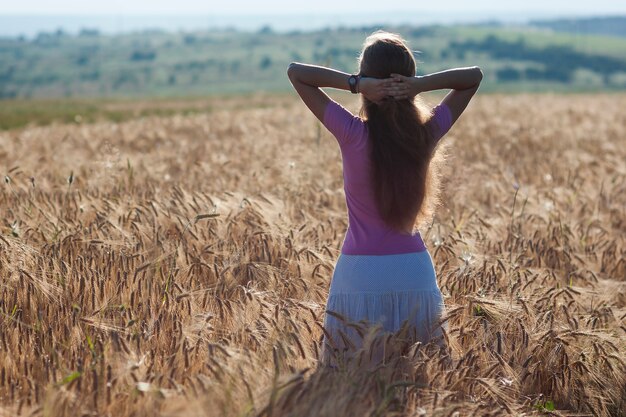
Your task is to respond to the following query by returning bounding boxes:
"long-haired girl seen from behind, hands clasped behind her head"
[287,31,482,367]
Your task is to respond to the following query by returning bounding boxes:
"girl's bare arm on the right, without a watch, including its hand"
[390,67,483,124]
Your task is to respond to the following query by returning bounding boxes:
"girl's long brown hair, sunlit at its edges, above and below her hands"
[359,31,438,233]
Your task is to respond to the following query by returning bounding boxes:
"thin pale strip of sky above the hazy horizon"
[0,0,626,15]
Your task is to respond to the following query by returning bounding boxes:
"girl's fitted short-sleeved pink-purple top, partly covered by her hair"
[323,99,452,255]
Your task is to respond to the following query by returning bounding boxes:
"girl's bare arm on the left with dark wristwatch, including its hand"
[287,62,393,121]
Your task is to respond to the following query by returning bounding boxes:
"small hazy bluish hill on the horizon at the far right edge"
[530,16,626,37]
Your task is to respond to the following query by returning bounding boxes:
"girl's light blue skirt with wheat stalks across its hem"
[321,250,447,367]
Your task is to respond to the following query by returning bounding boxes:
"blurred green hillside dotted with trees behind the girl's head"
[0,24,626,99]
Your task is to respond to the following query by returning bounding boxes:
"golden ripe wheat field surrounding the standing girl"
[0,94,626,417]
